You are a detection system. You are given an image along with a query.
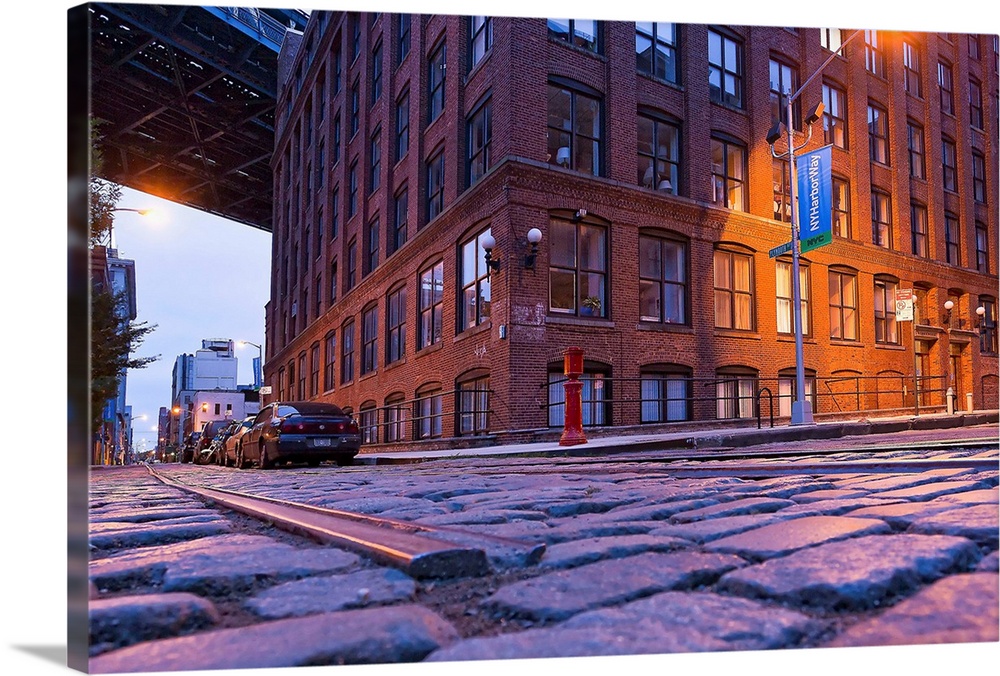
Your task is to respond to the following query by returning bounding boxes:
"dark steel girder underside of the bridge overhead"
[89,3,304,231]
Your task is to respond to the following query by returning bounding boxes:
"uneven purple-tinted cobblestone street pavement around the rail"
[89,428,1000,673]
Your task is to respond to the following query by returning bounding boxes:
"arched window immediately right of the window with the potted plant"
[639,235,688,324]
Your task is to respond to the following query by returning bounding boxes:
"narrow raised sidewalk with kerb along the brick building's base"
[354,411,1000,465]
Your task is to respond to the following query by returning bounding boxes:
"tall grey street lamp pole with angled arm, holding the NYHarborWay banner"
[767,30,861,425]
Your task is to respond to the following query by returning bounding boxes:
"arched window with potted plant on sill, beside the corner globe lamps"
[549,220,608,317]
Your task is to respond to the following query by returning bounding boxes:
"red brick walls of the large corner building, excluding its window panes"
[265,12,998,443]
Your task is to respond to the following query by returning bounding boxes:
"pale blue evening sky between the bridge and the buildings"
[114,188,271,450]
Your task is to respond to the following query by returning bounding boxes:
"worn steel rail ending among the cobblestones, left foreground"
[146,465,545,578]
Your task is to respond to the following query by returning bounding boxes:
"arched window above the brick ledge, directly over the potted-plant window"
[548,83,602,176]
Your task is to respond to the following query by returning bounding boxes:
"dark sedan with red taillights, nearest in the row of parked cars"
[240,401,361,469]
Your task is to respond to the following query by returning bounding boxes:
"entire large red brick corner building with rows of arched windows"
[265,12,998,444]
